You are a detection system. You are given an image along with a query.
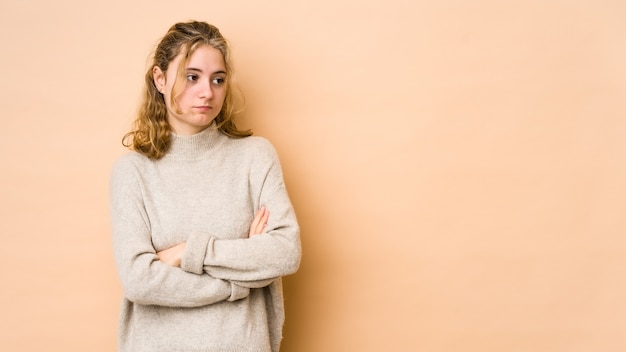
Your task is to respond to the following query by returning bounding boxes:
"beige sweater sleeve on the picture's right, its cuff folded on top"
[181,142,301,282]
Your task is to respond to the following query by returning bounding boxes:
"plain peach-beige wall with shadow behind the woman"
[0,0,626,352]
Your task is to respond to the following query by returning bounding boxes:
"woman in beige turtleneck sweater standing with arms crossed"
[111,22,301,352]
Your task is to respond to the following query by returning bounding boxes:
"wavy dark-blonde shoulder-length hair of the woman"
[122,21,252,159]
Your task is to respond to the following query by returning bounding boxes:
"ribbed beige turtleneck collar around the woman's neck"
[165,123,222,159]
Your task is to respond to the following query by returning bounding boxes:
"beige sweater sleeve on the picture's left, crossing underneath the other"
[110,160,249,307]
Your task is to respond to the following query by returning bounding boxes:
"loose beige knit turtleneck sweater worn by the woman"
[110,128,301,352]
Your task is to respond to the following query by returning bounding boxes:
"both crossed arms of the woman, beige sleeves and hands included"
[111,142,300,307]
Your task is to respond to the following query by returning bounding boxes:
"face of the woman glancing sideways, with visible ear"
[153,45,226,135]
